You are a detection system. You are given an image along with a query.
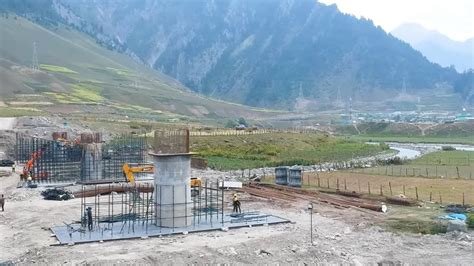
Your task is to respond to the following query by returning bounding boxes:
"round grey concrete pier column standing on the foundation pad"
[150,153,193,227]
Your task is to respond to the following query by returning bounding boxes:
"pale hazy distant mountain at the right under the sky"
[390,23,474,72]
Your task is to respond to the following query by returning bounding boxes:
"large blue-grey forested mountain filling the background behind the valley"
[0,0,474,111]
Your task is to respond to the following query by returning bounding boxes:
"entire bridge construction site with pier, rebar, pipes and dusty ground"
[0,118,474,265]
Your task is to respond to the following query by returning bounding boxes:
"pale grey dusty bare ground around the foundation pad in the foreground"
[0,169,474,265]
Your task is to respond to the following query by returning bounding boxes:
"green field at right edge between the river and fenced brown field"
[354,151,474,179]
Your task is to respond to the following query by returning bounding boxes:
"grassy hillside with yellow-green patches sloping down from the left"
[0,14,282,120]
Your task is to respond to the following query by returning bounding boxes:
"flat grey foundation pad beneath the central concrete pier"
[51,213,290,245]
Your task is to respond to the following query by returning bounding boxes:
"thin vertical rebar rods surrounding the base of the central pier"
[75,182,225,234]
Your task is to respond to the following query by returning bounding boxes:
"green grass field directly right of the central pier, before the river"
[191,133,383,170]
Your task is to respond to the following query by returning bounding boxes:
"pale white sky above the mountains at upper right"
[319,0,474,41]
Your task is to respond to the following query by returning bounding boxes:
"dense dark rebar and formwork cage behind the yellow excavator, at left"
[15,132,147,183]
